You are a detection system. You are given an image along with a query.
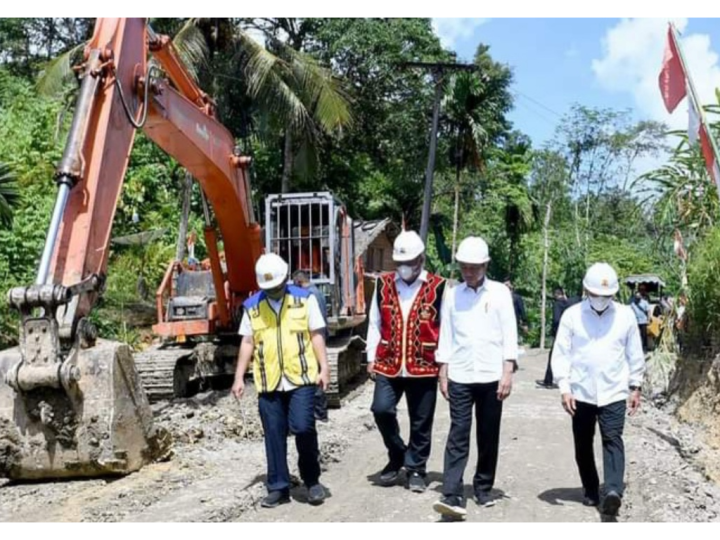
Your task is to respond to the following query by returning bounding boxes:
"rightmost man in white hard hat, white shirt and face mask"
[552,264,645,516]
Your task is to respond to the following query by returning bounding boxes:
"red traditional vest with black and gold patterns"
[375,274,446,377]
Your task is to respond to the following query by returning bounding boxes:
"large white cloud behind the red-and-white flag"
[593,17,720,129]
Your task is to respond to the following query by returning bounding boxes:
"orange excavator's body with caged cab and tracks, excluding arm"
[135,192,366,407]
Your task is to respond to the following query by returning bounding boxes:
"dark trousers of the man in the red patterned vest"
[372,375,438,476]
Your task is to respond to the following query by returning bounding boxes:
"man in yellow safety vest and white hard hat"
[232,254,330,508]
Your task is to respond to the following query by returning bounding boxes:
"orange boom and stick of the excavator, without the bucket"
[38,17,262,344]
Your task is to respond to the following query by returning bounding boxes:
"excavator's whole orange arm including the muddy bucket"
[0,17,262,479]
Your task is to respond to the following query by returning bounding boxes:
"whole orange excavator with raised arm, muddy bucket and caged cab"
[0,17,364,480]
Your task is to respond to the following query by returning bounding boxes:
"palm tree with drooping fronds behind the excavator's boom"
[39,17,353,196]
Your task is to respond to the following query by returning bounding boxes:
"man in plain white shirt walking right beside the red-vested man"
[435,238,518,520]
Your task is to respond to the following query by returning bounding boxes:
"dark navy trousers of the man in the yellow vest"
[259,386,320,493]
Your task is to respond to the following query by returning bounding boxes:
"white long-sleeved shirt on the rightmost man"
[552,300,645,407]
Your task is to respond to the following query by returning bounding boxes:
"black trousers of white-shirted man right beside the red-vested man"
[443,381,503,497]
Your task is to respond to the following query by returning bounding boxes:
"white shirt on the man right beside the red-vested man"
[437,279,518,384]
